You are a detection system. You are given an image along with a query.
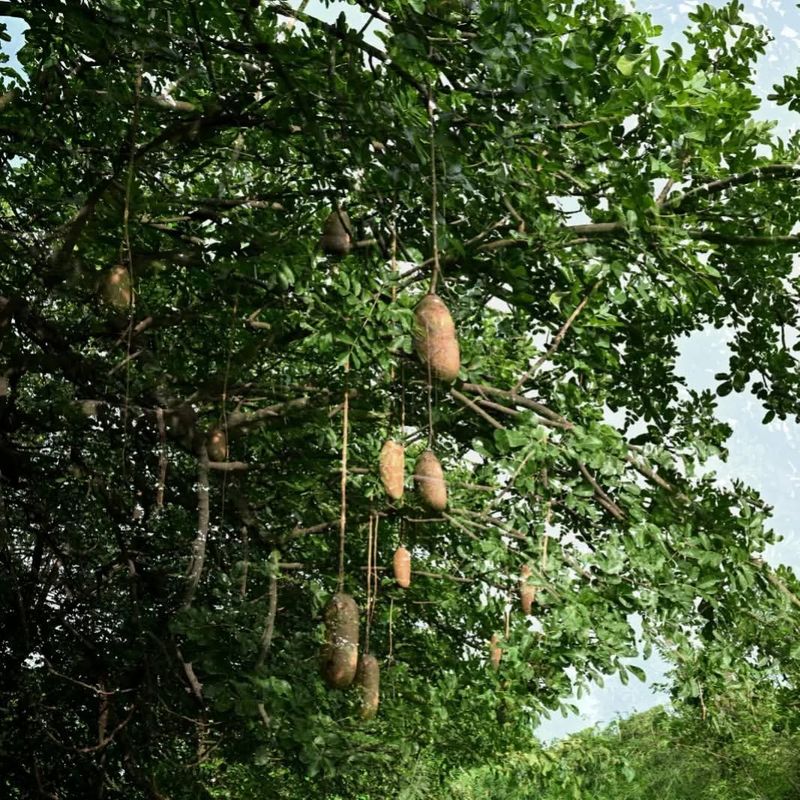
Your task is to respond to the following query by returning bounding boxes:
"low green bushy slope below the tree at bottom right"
[442,692,800,800]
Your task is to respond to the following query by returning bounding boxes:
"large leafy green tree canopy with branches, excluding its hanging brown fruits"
[0,0,800,798]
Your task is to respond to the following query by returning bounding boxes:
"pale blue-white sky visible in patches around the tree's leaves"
[0,0,800,740]
